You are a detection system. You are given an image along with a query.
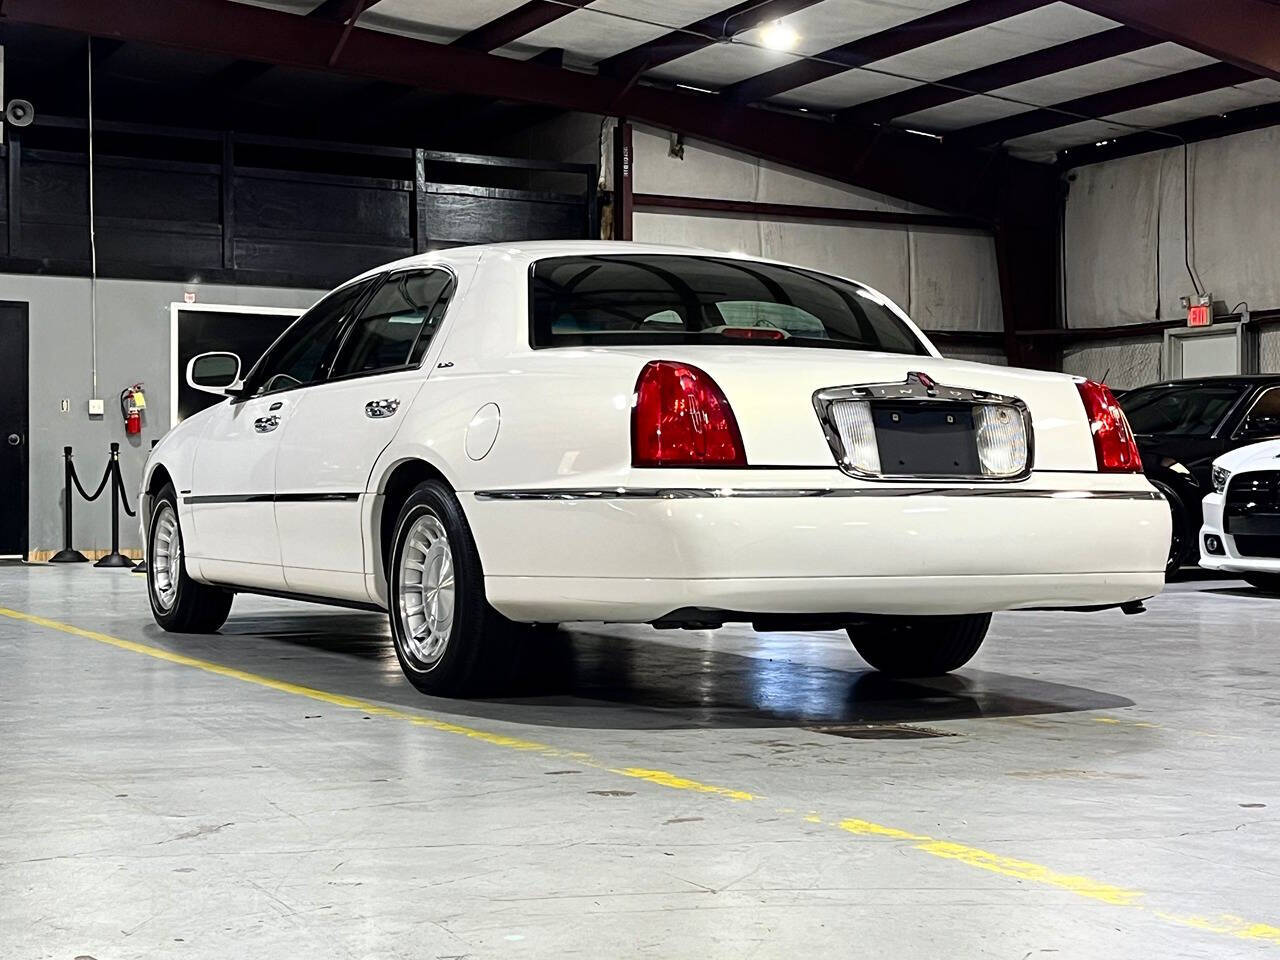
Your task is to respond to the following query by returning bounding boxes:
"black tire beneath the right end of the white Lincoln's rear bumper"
[847,613,991,677]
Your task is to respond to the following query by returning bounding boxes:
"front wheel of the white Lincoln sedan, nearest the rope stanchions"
[147,484,236,634]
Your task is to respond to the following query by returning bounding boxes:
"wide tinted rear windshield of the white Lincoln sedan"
[530,253,928,355]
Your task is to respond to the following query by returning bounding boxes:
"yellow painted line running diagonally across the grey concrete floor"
[0,607,1280,946]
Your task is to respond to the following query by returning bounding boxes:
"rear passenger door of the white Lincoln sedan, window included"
[275,268,456,600]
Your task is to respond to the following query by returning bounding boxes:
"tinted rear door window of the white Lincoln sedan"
[333,270,453,376]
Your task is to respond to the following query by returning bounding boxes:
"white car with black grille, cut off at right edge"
[1199,440,1280,593]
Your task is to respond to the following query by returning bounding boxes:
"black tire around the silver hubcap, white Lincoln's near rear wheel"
[387,480,526,696]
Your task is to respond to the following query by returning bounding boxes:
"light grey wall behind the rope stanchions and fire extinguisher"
[0,274,321,552]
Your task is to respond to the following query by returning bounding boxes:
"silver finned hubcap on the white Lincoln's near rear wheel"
[397,515,454,667]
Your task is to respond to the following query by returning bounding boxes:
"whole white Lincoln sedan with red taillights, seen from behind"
[142,242,1169,694]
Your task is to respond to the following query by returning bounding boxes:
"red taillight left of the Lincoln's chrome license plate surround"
[631,360,746,467]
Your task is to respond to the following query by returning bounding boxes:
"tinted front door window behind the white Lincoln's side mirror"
[246,280,372,397]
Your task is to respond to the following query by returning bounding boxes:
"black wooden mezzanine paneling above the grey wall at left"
[0,118,595,287]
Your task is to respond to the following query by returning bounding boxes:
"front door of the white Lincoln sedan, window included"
[183,283,369,590]
